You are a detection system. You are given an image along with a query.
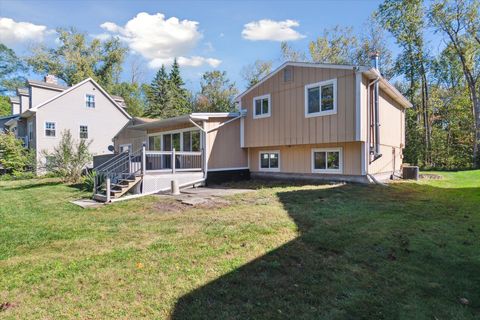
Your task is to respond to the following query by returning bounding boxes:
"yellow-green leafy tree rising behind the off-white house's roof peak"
[27,28,127,91]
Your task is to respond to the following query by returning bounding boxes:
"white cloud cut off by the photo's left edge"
[0,18,53,45]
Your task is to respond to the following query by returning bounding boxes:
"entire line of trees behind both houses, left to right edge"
[0,0,480,169]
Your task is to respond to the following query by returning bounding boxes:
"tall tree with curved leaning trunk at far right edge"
[429,0,480,167]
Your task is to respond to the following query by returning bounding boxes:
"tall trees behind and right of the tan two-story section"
[281,0,480,169]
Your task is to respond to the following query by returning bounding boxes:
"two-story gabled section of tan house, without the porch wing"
[237,62,411,182]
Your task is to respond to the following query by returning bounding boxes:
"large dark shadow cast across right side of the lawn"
[172,184,480,320]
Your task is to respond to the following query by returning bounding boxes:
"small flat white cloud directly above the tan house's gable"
[242,19,305,41]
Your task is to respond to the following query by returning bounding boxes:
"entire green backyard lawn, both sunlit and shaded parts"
[0,171,480,319]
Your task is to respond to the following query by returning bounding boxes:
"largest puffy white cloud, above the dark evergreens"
[102,12,221,68]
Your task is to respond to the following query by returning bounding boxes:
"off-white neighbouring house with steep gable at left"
[5,76,131,169]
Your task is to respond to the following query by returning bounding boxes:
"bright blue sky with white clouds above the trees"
[0,0,404,90]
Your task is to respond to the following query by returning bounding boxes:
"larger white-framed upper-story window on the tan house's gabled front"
[305,79,337,117]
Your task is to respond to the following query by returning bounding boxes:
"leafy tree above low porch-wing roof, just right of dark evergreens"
[195,70,238,112]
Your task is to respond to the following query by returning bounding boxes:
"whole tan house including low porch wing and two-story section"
[103,58,411,201]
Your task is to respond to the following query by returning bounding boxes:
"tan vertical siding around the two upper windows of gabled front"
[241,66,356,147]
